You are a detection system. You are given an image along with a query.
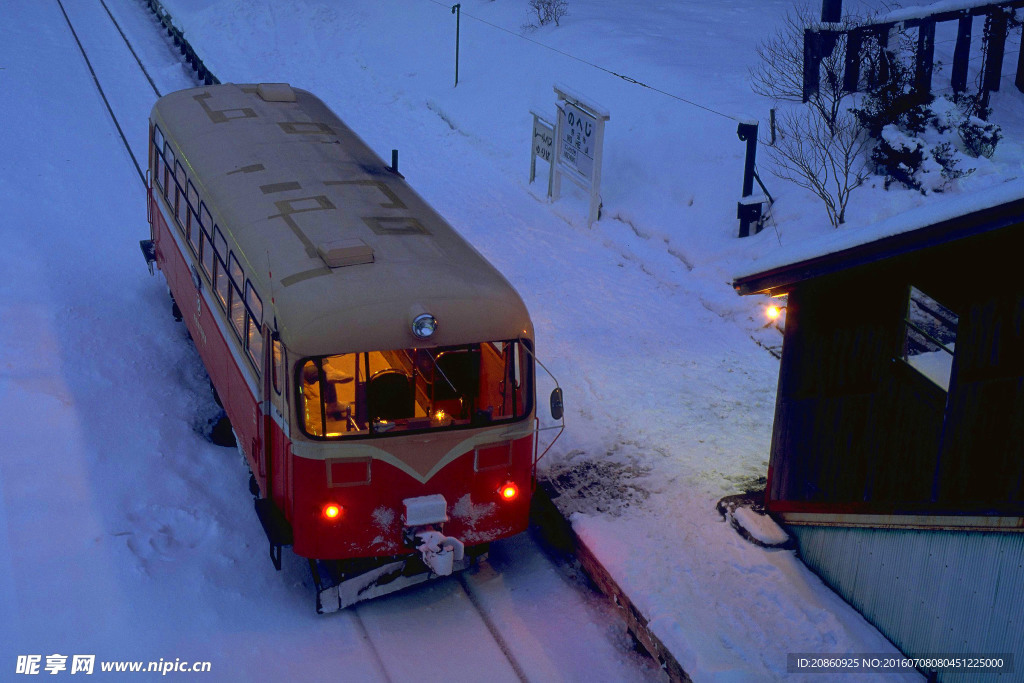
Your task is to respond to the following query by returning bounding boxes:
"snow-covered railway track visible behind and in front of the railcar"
[53,0,660,681]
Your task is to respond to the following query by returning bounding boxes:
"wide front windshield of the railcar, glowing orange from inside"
[297,341,534,439]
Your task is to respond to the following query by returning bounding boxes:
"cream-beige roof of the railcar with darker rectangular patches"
[152,84,532,355]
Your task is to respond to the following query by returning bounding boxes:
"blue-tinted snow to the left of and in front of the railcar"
[0,0,657,681]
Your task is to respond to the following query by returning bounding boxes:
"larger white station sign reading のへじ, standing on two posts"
[551,85,611,225]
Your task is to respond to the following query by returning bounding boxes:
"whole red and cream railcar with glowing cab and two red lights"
[142,84,561,611]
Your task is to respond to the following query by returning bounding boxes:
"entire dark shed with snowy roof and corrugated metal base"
[734,192,1024,683]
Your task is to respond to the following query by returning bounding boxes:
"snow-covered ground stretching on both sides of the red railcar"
[0,0,1024,681]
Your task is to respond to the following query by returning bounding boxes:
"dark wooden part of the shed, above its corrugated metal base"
[734,194,1024,531]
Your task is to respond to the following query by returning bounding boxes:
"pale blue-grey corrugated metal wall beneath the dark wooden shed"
[788,525,1024,683]
